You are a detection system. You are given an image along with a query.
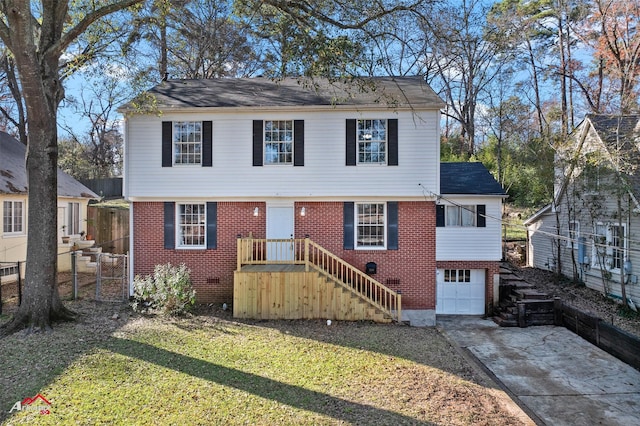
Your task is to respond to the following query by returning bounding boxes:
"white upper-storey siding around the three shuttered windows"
[125,110,439,199]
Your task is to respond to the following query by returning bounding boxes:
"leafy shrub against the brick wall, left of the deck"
[131,263,196,315]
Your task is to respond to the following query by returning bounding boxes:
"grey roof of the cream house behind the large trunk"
[0,132,100,198]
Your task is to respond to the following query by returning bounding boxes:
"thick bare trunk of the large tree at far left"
[3,2,73,334]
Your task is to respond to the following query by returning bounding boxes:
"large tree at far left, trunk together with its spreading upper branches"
[0,0,142,333]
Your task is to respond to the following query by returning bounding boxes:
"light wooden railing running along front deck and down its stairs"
[237,237,402,321]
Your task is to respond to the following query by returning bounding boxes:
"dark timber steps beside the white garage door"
[493,264,554,327]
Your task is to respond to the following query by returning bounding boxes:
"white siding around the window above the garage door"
[436,196,502,261]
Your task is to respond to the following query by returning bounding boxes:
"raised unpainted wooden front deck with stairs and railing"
[233,237,402,322]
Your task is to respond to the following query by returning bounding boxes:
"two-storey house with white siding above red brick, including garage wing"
[120,77,503,325]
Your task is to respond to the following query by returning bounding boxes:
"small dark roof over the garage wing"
[440,162,507,196]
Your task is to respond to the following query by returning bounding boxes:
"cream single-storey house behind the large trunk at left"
[0,132,98,275]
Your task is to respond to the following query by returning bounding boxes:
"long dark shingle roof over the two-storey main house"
[119,76,444,112]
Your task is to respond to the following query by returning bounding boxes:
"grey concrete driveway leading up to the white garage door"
[437,316,640,426]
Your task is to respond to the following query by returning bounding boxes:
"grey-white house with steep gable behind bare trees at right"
[525,114,640,303]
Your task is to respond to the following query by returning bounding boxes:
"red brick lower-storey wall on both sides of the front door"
[132,202,436,309]
